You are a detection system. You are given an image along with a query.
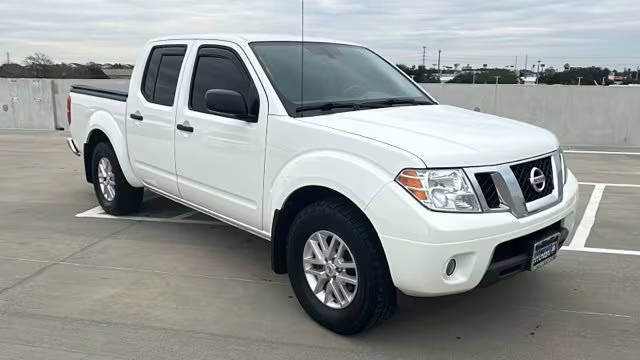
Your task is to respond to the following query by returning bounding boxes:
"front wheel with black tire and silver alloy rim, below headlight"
[287,199,396,335]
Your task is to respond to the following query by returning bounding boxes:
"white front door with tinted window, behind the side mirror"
[175,42,268,229]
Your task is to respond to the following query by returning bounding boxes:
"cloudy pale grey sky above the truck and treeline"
[0,0,640,70]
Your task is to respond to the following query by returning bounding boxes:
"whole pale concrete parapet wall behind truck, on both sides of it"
[0,79,640,146]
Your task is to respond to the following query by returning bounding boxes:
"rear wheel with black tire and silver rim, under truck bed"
[91,142,144,215]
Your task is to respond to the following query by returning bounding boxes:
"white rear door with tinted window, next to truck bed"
[126,42,188,195]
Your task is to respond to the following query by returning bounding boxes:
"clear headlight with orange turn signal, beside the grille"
[396,169,480,212]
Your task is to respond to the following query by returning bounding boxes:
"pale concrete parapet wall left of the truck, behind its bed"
[0,79,129,130]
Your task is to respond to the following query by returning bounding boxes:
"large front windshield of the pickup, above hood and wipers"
[251,42,433,117]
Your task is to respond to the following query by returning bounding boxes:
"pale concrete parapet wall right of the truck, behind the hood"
[422,84,640,146]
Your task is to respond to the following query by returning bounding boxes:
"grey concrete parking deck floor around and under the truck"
[0,131,640,360]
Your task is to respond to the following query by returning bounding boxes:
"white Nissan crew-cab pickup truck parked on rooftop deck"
[68,35,578,334]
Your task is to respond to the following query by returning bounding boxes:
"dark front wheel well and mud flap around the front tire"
[271,186,373,274]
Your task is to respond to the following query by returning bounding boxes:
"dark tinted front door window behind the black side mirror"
[189,47,259,116]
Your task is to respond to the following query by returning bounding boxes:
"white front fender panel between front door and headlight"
[263,115,424,232]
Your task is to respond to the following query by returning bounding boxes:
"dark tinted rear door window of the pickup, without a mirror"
[142,46,186,106]
